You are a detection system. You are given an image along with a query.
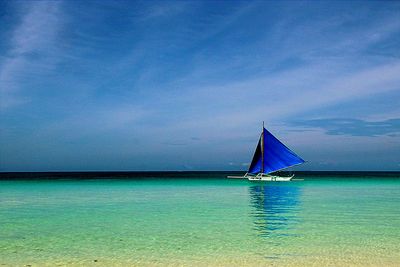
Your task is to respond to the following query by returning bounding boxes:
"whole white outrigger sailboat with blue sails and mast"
[228,122,305,182]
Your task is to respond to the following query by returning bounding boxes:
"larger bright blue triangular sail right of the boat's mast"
[264,128,304,173]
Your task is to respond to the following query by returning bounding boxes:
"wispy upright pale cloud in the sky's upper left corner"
[0,1,61,109]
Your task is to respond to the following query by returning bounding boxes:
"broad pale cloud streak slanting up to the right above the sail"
[138,59,400,141]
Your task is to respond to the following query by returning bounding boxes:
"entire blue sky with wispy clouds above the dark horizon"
[0,0,400,171]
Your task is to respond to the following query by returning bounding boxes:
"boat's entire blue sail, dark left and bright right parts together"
[248,128,304,174]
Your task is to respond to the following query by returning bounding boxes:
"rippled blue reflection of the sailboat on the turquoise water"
[249,184,300,237]
